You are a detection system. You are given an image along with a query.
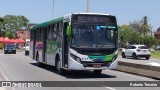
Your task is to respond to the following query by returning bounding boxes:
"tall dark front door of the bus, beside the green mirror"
[62,22,68,68]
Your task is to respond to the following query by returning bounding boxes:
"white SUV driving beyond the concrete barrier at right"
[122,45,151,60]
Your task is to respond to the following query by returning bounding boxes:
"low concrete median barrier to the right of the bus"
[116,61,160,79]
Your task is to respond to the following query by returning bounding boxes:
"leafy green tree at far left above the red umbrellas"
[3,15,29,37]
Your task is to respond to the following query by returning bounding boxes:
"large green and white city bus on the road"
[29,13,118,74]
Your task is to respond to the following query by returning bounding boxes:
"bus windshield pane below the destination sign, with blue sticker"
[71,23,117,48]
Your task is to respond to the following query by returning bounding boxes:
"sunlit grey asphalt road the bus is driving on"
[0,52,160,90]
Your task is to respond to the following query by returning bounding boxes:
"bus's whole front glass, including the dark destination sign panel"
[71,15,118,48]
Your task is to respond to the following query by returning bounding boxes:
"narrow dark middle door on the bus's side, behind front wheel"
[42,28,47,62]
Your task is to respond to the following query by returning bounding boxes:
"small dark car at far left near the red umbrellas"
[4,44,16,54]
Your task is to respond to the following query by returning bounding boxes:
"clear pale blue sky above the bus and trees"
[0,0,160,31]
